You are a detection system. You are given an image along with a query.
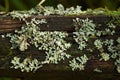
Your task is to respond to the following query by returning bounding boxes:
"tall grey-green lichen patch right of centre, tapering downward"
[73,18,96,50]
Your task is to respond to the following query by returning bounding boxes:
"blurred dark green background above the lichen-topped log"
[0,0,120,80]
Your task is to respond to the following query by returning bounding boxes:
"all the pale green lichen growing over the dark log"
[2,4,120,73]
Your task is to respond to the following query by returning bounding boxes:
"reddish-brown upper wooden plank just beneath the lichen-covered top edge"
[0,15,111,32]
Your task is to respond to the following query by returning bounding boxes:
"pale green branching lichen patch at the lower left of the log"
[11,57,42,72]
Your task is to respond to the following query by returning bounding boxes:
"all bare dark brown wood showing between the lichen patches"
[0,15,120,80]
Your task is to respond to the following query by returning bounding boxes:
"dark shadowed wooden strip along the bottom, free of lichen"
[0,70,120,80]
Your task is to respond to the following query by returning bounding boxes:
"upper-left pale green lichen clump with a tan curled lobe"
[7,18,46,51]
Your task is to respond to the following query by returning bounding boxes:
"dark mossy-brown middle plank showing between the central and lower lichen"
[0,36,118,73]
